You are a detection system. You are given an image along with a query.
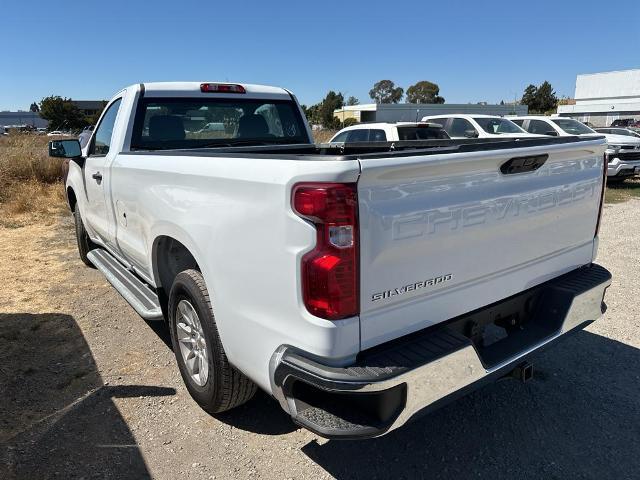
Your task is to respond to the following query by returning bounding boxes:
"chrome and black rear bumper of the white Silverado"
[270,264,611,438]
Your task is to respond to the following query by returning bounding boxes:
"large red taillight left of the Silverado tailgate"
[291,183,359,320]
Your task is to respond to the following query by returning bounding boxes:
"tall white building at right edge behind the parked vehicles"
[558,69,640,127]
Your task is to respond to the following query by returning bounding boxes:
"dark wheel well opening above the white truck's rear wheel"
[153,236,200,292]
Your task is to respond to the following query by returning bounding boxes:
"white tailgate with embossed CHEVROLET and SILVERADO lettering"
[358,139,605,349]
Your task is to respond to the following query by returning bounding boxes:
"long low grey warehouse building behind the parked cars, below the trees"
[333,102,528,122]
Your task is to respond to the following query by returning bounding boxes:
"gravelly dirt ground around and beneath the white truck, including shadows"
[0,199,640,479]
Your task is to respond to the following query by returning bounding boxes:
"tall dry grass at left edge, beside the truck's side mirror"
[0,134,64,227]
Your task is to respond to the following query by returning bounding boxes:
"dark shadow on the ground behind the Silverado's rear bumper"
[302,331,640,479]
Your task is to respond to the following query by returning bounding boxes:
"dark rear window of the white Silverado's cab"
[131,97,309,150]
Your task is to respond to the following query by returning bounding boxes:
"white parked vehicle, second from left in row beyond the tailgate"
[422,114,531,138]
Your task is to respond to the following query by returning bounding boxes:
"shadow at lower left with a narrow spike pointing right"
[0,313,176,479]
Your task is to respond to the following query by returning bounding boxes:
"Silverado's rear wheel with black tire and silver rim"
[169,270,257,414]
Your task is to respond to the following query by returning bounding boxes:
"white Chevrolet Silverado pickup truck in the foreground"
[49,83,611,438]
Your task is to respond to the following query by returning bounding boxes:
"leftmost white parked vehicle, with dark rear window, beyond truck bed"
[329,122,449,143]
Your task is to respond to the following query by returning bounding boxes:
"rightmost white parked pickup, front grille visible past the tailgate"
[511,115,640,182]
